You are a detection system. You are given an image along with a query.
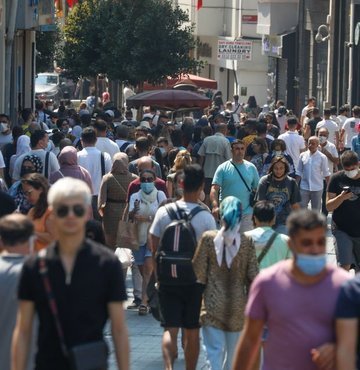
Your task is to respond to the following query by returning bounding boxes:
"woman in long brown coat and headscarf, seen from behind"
[98,153,137,250]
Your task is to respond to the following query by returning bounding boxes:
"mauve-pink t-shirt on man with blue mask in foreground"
[245,261,349,370]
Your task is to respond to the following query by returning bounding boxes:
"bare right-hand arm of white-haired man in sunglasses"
[108,302,130,370]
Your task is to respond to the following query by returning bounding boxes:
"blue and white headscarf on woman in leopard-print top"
[214,196,242,268]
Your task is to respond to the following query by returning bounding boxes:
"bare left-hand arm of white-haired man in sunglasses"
[11,301,35,370]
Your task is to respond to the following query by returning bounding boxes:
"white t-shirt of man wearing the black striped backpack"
[149,200,216,241]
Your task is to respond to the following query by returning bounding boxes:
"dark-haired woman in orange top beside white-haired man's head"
[21,173,55,252]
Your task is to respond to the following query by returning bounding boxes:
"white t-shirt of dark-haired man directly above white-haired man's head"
[77,146,112,195]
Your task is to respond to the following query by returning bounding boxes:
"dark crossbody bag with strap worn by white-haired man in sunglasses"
[39,249,108,370]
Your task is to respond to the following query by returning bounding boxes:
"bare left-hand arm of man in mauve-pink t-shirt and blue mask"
[232,317,265,370]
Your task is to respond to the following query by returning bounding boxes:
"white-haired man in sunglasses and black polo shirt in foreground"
[12,177,129,370]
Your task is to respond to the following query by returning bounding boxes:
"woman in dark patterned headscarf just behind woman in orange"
[9,154,43,215]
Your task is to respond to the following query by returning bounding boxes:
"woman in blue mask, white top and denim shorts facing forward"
[129,170,166,315]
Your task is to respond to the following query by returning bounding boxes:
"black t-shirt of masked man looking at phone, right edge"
[328,171,360,238]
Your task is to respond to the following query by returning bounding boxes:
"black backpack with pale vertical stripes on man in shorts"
[156,203,207,285]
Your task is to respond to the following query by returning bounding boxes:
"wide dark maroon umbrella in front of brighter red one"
[126,89,210,110]
